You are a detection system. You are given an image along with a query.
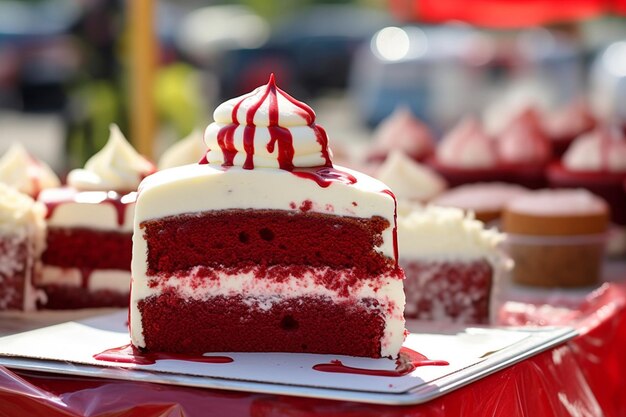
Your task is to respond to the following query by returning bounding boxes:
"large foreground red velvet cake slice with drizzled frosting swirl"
[130,77,404,357]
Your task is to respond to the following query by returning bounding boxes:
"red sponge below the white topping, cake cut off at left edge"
[0,236,33,310]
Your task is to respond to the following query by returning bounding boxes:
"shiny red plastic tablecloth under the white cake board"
[0,283,626,417]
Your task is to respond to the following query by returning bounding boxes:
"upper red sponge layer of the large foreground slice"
[141,209,394,276]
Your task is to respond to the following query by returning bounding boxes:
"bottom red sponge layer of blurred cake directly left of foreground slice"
[38,285,129,310]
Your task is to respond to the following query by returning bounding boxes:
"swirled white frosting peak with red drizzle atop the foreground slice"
[204,74,332,171]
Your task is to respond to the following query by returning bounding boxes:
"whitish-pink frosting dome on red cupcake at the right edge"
[563,128,626,172]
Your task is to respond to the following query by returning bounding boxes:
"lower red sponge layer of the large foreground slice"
[139,292,384,357]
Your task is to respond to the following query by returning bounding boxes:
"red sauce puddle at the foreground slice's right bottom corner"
[313,347,450,377]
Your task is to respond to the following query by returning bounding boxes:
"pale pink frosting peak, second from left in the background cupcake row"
[437,117,498,169]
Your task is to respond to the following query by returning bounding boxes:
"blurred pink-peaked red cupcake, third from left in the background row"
[496,107,552,188]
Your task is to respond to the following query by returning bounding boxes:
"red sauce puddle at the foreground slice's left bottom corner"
[93,345,233,365]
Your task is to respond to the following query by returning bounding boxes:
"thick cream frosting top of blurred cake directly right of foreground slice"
[398,206,504,261]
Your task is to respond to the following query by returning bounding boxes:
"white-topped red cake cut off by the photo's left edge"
[0,183,45,310]
